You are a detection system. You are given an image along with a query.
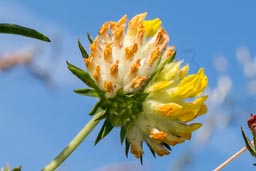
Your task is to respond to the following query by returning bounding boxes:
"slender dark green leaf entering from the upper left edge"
[0,23,51,42]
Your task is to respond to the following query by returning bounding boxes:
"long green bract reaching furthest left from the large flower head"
[67,61,98,91]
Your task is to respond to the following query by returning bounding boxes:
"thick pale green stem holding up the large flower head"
[42,111,104,171]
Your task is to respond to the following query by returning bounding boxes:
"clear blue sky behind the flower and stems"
[0,0,256,171]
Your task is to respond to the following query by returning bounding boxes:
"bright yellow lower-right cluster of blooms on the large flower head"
[126,62,207,157]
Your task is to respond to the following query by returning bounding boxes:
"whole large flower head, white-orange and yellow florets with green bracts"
[68,13,207,158]
